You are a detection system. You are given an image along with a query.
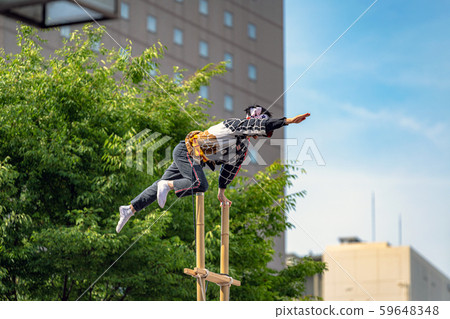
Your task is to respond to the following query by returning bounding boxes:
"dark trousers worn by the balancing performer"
[131,141,208,211]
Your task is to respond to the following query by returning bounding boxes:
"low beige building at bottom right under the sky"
[298,240,450,301]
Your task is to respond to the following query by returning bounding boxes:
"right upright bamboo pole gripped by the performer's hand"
[220,203,230,301]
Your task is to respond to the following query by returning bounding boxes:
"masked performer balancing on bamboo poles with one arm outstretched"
[116,105,310,232]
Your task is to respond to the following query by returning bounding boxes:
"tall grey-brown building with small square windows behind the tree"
[0,0,285,269]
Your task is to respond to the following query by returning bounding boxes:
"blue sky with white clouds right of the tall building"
[284,0,450,277]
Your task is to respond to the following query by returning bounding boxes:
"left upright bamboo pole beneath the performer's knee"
[196,193,206,301]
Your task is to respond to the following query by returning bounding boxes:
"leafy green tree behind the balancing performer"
[0,26,323,300]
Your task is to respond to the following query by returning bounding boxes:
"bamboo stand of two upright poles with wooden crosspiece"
[184,193,241,301]
